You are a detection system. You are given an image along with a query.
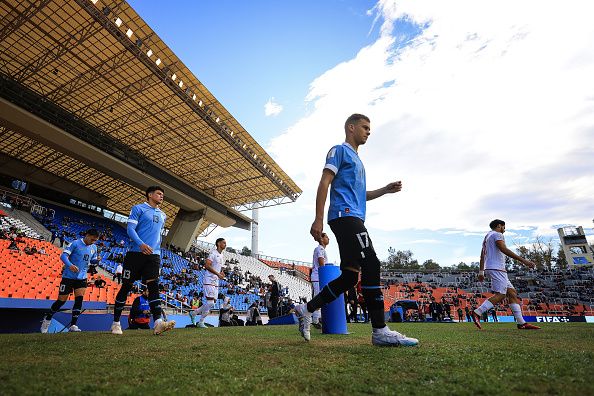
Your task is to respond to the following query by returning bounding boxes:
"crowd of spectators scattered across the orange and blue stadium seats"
[0,196,594,324]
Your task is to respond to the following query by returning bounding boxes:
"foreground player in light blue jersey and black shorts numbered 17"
[295,114,419,346]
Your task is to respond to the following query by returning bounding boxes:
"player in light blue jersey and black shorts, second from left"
[111,186,175,335]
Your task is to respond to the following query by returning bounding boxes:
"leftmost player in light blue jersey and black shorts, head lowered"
[41,228,99,333]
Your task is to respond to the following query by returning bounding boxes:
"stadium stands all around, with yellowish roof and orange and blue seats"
[0,0,594,331]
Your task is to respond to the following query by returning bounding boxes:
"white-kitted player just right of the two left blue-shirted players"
[196,238,227,327]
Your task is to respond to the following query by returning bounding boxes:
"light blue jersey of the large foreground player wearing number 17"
[324,142,367,221]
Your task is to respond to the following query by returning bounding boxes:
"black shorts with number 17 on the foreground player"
[328,216,380,286]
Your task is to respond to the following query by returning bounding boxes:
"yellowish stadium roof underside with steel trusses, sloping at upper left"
[0,0,301,227]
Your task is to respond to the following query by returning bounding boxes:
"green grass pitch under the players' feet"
[0,323,594,395]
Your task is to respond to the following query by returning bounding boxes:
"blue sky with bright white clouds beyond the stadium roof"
[129,0,594,266]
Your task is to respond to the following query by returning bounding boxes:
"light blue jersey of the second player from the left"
[128,202,167,254]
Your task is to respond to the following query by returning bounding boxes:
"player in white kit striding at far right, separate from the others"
[471,219,540,330]
